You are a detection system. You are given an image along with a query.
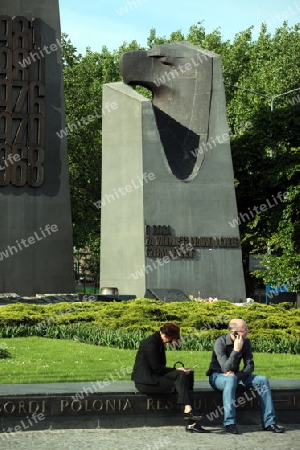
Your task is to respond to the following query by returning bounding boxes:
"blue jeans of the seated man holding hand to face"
[209,373,276,428]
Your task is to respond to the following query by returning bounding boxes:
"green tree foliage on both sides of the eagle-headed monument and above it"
[59,22,300,295]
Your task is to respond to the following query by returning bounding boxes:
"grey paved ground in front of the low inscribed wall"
[0,425,300,450]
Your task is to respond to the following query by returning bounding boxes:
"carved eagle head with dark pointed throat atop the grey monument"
[121,42,213,181]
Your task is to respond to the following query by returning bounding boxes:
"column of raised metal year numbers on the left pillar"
[0,16,45,188]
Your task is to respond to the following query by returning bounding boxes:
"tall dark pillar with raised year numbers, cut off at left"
[0,0,75,296]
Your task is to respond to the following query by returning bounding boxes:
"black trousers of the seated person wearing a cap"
[135,370,193,406]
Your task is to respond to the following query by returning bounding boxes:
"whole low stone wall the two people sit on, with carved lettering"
[0,379,300,433]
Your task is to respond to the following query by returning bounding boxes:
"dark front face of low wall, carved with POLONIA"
[0,390,300,417]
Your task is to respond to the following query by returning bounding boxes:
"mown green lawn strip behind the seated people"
[0,337,300,384]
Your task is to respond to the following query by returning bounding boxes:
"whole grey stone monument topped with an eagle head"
[100,42,246,301]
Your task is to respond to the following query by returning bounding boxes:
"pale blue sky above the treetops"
[59,0,300,54]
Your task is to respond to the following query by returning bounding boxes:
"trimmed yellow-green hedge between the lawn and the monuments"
[0,299,300,354]
